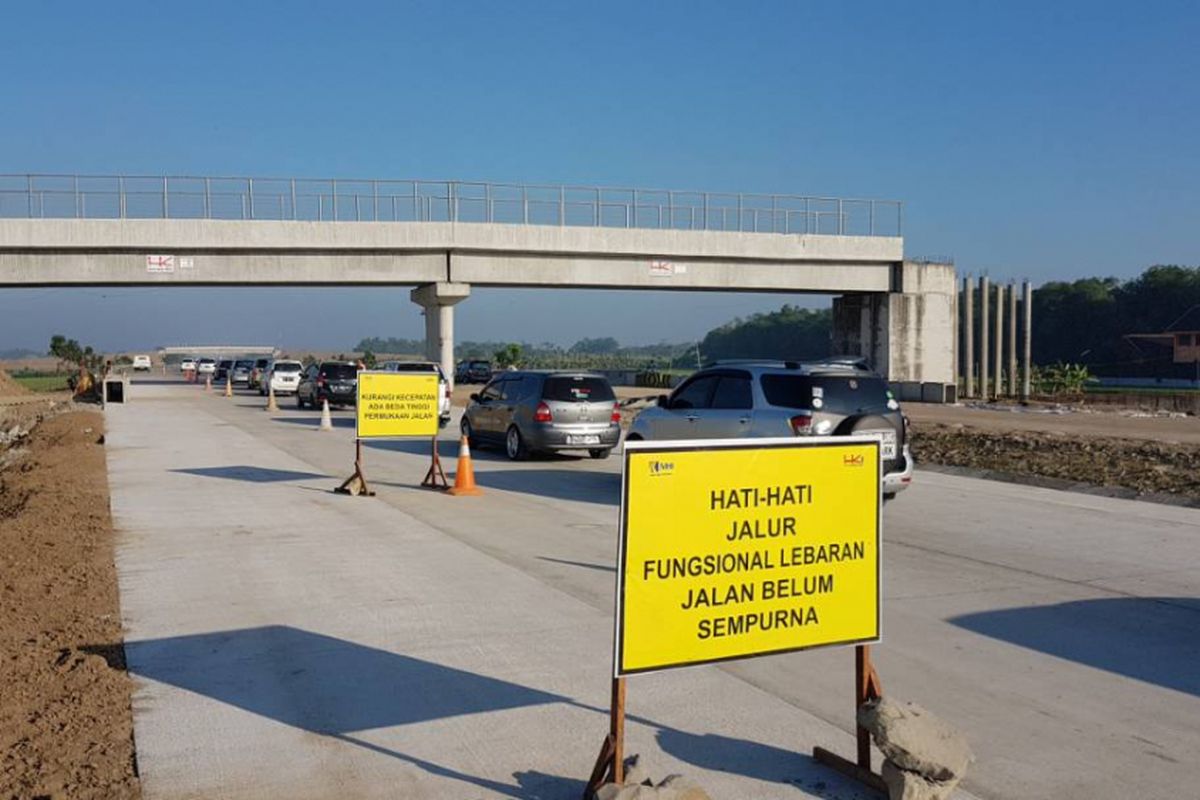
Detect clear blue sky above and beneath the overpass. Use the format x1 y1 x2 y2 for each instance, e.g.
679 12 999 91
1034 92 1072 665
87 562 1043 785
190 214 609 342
0 1 1200 349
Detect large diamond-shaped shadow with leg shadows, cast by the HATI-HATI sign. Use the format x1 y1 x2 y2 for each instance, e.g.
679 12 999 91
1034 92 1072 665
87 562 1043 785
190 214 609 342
98 625 858 800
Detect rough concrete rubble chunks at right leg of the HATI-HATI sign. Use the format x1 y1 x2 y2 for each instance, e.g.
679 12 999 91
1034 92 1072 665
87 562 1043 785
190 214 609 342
858 697 974 800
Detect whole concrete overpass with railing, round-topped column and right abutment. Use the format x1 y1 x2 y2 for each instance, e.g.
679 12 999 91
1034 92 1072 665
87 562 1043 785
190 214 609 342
0 175 956 399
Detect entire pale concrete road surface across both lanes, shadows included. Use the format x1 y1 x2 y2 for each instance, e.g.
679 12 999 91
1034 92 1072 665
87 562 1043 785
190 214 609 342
109 385 1200 800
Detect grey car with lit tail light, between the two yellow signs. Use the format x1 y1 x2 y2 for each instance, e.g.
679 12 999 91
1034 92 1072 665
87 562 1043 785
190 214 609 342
461 369 620 461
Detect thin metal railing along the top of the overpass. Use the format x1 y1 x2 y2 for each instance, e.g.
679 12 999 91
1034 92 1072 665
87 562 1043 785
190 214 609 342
0 175 904 236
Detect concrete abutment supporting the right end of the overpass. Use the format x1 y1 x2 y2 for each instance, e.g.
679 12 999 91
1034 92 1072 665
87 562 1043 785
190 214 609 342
833 261 958 403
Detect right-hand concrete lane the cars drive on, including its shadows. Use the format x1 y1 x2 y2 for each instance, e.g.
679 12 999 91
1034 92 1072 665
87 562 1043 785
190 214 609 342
180 381 1200 800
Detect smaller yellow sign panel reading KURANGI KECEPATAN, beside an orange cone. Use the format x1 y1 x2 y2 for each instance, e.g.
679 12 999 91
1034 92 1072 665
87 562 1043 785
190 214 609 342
358 372 438 439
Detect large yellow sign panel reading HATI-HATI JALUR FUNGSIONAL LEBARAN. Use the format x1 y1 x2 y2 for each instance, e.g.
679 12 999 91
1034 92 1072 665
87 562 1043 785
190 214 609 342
616 437 881 676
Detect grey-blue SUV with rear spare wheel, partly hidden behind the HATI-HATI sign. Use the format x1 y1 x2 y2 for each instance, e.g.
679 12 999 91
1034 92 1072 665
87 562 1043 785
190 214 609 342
628 359 913 498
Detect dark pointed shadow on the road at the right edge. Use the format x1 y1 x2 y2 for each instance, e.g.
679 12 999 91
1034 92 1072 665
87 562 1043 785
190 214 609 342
949 597 1200 696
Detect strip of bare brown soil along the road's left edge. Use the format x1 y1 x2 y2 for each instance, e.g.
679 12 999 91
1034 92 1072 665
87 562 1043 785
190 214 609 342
0 409 140 800
